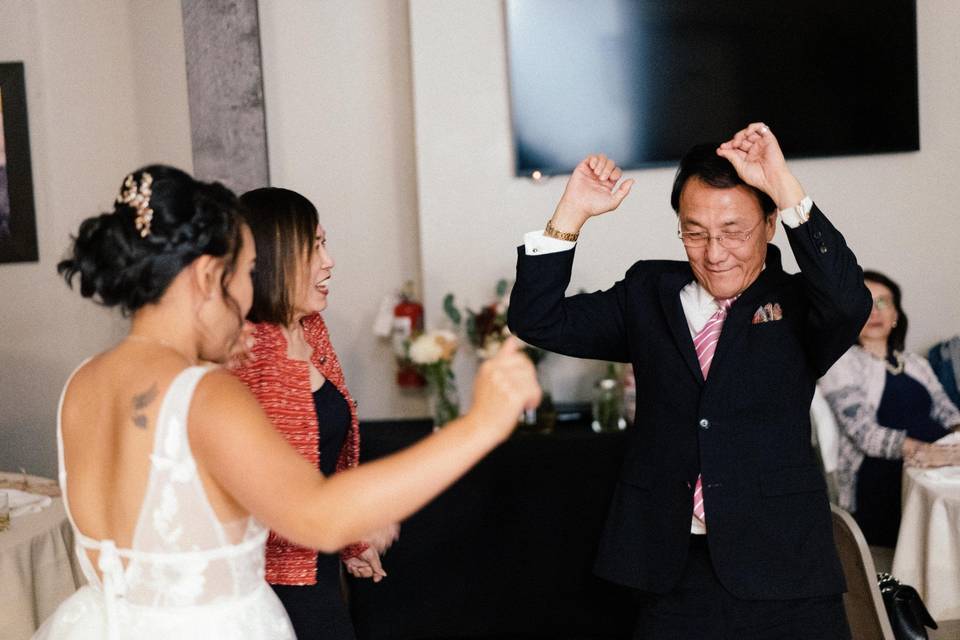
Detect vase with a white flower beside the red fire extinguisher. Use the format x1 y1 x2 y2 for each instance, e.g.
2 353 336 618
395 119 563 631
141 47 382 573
410 330 460 429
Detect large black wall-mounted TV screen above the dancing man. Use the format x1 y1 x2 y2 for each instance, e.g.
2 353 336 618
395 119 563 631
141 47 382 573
505 0 920 175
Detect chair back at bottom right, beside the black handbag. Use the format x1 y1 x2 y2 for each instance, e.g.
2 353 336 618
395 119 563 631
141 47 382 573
830 504 895 640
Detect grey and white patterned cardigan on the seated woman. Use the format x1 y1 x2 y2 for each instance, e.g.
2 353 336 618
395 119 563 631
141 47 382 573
819 346 960 512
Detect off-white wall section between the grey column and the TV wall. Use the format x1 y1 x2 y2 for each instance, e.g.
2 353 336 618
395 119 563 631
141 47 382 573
260 0 426 419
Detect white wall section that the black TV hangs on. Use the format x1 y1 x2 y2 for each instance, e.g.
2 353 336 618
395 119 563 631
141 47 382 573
410 0 960 398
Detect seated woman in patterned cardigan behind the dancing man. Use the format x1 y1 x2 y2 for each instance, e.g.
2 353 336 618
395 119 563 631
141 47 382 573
819 271 960 547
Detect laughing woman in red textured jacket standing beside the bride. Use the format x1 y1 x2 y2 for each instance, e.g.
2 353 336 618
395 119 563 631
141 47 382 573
234 188 396 640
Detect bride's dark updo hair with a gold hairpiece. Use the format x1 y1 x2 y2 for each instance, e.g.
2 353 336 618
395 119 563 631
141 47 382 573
57 165 242 315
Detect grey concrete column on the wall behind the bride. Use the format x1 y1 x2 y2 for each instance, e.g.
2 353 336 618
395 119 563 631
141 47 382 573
181 0 270 194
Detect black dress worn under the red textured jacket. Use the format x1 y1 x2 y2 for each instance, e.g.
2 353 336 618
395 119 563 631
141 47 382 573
271 381 356 640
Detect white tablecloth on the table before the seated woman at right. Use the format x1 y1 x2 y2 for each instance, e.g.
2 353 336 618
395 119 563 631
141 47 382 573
892 467 960 620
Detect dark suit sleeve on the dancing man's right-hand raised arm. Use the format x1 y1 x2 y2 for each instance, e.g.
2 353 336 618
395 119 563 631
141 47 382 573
785 206 873 376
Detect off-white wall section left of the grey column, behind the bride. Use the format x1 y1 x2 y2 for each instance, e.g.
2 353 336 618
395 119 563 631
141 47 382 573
0 0 190 476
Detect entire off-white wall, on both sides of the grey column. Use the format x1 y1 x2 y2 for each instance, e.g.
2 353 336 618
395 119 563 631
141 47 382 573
0 0 960 475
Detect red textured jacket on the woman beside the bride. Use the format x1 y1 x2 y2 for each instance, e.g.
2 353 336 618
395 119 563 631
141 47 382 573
234 314 367 585
